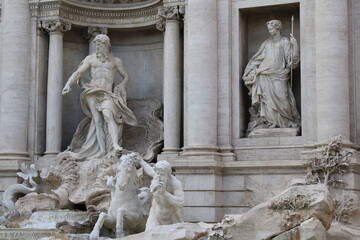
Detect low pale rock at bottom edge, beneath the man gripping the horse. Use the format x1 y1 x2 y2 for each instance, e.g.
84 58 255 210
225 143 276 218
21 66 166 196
122 222 212 240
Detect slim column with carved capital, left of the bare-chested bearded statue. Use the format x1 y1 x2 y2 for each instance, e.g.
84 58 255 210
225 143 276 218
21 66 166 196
42 20 71 156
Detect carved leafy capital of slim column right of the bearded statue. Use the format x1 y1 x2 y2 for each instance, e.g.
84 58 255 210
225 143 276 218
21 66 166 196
156 5 185 31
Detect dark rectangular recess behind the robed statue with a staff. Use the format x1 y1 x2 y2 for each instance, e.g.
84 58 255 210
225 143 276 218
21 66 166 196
238 3 302 138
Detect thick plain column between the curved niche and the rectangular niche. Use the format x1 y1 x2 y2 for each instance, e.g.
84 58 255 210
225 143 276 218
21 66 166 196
183 0 218 155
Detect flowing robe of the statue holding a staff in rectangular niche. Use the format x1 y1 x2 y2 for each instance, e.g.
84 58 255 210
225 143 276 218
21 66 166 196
244 36 300 128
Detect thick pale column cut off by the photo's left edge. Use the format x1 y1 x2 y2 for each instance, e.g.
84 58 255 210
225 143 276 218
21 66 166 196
0 0 30 163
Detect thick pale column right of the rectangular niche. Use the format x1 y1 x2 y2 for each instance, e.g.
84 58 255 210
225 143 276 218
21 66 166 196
315 0 350 142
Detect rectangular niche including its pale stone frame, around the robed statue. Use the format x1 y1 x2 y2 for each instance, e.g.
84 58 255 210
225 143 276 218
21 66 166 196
232 0 304 138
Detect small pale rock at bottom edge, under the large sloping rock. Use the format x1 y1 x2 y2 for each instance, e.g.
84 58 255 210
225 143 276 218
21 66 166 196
273 218 326 240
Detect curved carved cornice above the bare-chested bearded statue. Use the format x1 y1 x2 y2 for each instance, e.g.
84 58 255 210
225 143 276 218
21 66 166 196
30 0 169 28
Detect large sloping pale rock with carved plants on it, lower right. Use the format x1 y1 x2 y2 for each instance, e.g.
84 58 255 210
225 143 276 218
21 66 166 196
224 184 335 240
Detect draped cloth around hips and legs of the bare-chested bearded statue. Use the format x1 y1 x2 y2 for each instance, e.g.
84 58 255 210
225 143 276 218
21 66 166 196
69 83 137 159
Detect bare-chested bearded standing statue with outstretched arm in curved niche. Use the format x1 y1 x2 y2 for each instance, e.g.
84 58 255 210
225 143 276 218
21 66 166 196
62 34 137 159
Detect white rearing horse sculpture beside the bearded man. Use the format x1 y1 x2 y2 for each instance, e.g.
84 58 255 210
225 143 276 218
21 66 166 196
90 153 151 240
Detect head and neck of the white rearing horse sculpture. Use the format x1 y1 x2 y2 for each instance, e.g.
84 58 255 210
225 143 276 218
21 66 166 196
116 152 139 191
